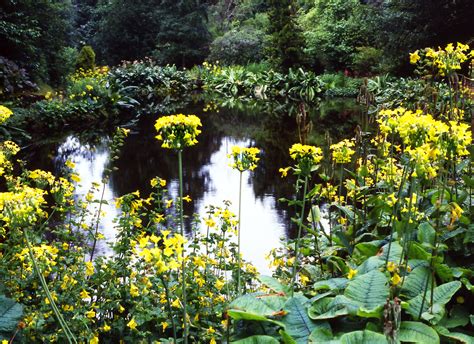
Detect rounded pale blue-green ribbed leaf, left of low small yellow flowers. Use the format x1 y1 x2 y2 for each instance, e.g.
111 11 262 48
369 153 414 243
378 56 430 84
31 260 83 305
344 270 390 310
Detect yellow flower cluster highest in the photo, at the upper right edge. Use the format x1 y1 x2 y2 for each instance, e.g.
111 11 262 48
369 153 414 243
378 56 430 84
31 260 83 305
410 42 474 76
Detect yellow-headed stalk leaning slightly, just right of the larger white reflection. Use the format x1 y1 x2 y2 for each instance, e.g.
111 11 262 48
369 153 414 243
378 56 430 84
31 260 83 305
283 143 323 295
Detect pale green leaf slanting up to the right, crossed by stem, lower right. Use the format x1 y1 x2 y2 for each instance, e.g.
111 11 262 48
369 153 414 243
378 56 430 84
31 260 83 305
407 281 461 319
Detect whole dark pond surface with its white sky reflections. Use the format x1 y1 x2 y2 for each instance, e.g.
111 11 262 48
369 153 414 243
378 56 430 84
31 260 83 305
22 99 363 273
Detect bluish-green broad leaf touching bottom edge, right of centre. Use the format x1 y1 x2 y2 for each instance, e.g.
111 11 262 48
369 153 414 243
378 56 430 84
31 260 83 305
281 297 329 343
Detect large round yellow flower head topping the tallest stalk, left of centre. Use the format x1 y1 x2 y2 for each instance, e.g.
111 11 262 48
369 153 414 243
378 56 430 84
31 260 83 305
155 114 202 149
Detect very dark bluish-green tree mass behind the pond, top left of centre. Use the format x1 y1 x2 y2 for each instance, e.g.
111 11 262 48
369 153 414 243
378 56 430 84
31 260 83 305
95 0 209 65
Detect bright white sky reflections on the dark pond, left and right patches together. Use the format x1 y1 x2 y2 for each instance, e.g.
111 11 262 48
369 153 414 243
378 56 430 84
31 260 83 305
58 137 285 274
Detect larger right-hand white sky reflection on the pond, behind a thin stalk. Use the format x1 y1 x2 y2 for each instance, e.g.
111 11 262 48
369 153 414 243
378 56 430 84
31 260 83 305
198 137 285 274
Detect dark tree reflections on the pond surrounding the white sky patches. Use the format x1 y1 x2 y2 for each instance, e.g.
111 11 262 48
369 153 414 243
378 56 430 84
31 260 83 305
25 100 360 236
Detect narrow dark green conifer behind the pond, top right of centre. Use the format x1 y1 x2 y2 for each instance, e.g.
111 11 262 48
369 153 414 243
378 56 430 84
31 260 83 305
266 0 304 70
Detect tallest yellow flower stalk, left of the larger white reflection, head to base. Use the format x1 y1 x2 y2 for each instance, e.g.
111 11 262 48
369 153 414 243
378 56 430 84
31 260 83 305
155 114 202 343
